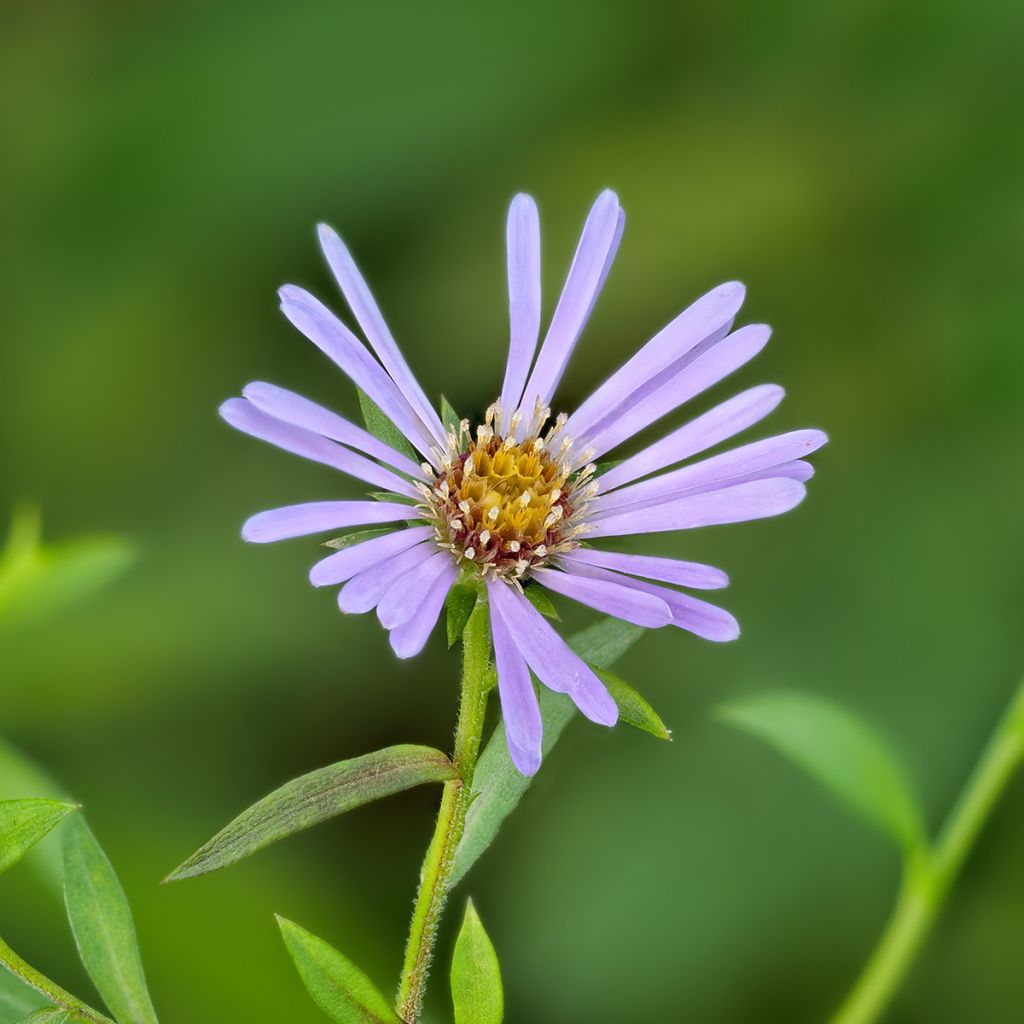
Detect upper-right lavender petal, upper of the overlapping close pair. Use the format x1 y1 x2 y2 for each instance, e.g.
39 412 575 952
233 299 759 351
565 281 745 438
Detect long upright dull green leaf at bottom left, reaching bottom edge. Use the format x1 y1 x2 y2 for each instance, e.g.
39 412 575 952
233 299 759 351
63 815 157 1024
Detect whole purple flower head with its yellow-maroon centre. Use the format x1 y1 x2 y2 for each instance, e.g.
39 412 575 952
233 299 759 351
221 191 826 775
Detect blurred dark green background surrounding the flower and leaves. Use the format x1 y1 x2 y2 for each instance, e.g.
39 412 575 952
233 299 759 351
0 0 1024 1024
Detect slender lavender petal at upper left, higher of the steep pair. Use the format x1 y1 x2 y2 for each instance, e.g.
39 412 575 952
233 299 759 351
317 224 444 447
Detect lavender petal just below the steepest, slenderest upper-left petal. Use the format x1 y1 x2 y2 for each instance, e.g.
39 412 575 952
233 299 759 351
278 285 437 458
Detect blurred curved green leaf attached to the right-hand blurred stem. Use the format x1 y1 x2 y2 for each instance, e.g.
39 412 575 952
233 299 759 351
718 692 924 850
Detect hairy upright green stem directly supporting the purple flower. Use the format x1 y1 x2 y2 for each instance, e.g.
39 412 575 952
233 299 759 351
395 596 490 1024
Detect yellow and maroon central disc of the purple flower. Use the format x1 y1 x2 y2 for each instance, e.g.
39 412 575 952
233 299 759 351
423 415 586 580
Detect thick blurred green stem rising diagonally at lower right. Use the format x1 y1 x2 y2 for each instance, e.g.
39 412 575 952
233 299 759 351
829 683 1024 1024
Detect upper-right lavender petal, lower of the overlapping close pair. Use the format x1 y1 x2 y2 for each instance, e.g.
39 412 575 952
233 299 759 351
587 324 771 459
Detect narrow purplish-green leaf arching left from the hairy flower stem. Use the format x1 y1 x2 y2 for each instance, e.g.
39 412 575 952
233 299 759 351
167 745 458 882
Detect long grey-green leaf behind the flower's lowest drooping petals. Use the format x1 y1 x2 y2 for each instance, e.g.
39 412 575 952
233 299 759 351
452 617 644 885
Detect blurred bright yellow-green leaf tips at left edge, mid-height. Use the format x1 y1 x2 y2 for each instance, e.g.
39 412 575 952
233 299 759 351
0 508 135 628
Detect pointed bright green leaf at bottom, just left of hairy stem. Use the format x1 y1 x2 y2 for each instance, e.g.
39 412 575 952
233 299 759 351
278 916 401 1024
